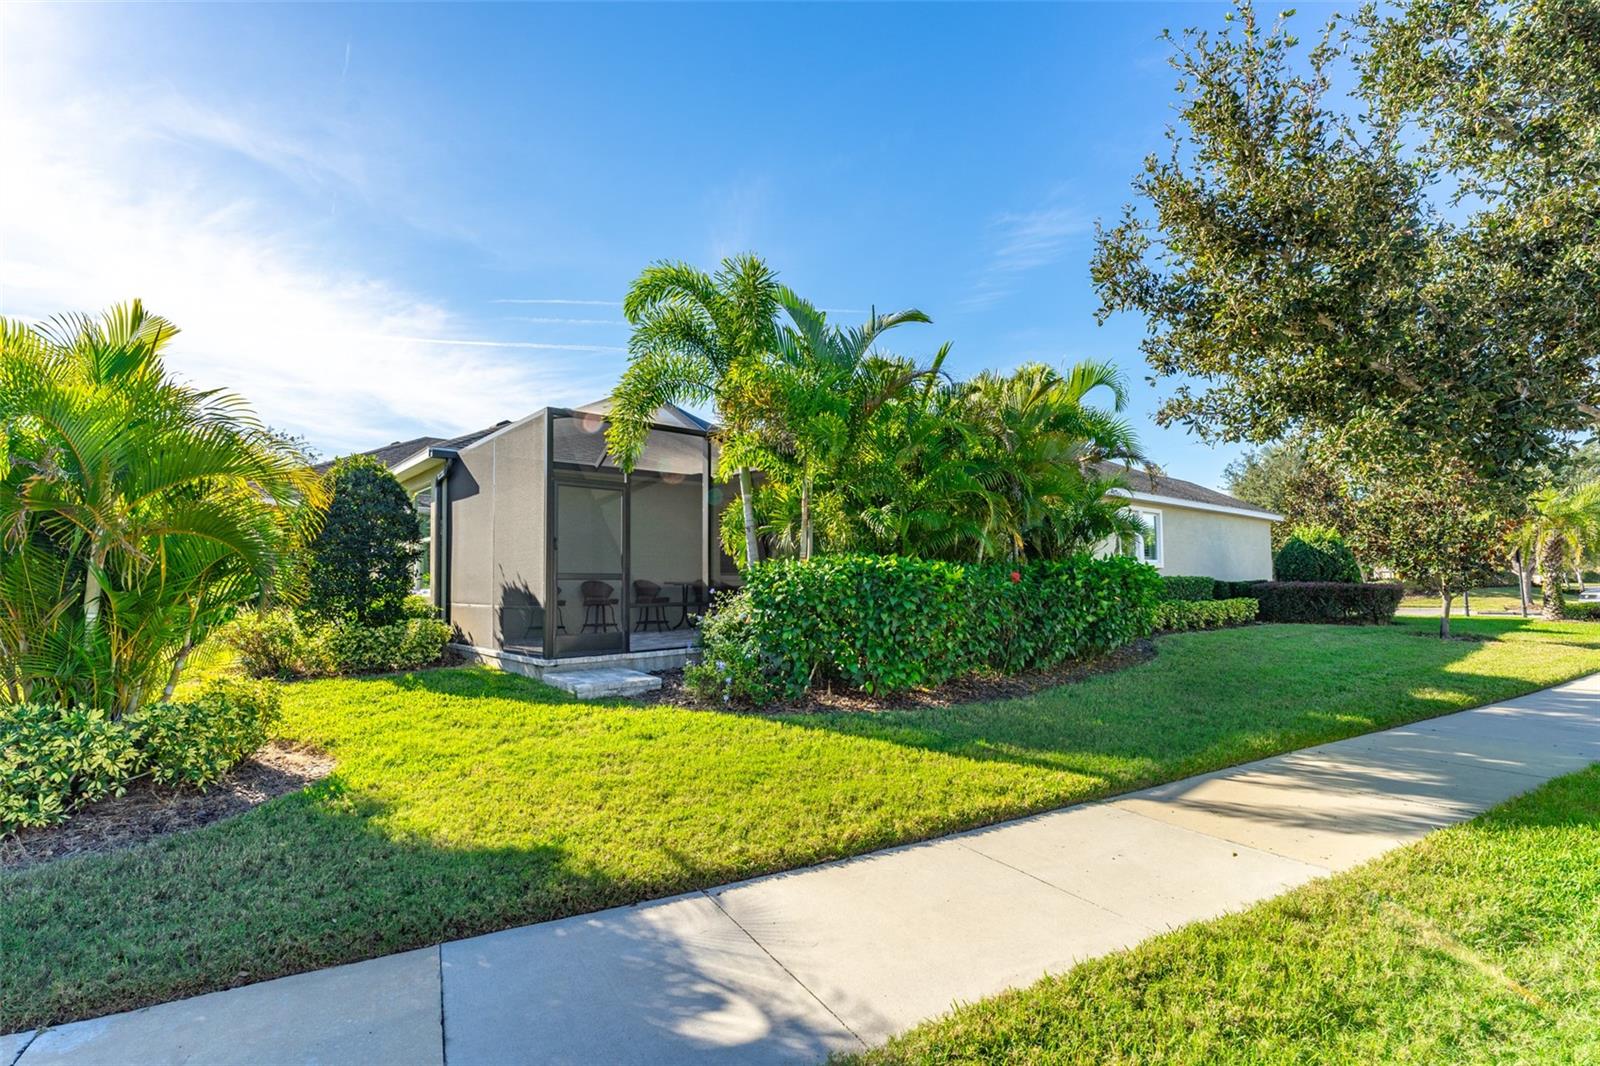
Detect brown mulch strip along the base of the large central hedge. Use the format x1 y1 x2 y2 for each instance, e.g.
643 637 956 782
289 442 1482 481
635 640 1155 714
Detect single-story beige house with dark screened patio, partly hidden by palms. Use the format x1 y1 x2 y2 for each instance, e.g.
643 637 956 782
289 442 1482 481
347 400 1278 672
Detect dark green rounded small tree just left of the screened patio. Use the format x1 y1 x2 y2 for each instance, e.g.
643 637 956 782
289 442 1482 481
306 455 422 626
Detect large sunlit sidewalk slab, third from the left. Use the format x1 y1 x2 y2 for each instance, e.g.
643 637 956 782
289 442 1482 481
710 839 1152 1044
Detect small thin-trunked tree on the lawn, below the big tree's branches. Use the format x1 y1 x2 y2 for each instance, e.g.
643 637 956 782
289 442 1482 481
1355 461 1509 639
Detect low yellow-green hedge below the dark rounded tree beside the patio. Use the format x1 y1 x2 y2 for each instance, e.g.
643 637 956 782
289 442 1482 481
218 597 450 679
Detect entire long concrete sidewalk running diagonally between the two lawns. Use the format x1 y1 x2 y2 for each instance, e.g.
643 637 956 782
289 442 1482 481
12 674 1600 1066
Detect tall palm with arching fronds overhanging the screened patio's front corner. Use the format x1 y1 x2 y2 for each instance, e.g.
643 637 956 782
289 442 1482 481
606 254 781 565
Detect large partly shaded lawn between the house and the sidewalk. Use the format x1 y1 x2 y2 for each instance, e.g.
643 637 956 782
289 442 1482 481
0 619 1600 1031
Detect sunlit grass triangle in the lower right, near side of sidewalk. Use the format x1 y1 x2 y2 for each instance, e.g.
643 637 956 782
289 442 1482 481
853 767 1600 1066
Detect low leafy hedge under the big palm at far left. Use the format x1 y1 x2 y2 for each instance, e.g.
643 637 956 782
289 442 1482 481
0 680 278 836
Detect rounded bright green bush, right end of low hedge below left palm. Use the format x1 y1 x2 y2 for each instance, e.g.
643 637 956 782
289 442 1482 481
126 680 278 789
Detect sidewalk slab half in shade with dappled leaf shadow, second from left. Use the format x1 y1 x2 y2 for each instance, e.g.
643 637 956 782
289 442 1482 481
442 893 861 1066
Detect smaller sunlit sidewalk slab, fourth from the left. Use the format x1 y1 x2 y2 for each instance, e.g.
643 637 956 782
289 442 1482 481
957 804 1328 930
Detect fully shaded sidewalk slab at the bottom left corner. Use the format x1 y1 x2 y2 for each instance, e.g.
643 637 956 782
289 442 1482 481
18 948 445 1066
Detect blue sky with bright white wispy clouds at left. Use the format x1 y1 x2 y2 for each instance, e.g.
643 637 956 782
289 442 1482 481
0 3 1350 485
